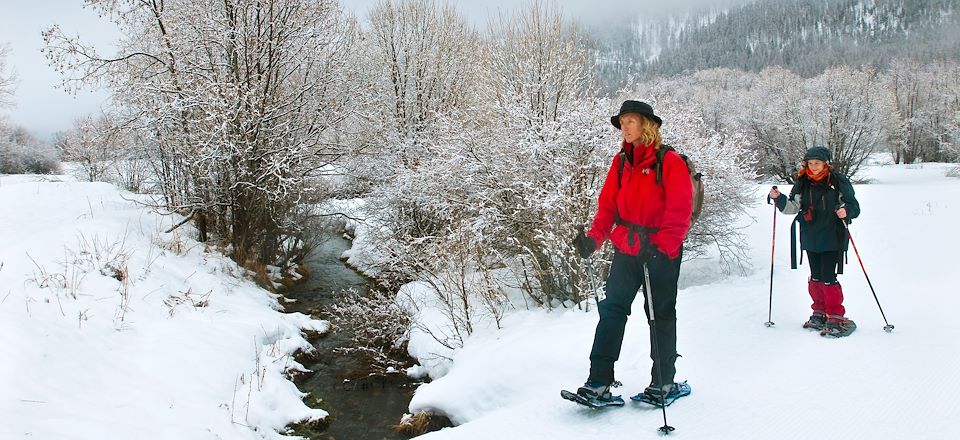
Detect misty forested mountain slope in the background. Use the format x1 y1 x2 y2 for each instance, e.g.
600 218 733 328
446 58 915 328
592 0 960 89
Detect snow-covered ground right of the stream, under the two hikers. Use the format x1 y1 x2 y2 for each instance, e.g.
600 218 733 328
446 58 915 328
411 164 960 440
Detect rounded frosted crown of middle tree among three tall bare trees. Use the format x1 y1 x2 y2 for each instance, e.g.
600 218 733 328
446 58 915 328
363 0 479 164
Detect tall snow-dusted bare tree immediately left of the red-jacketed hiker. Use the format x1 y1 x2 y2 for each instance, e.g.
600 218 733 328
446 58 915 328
473 1 600 307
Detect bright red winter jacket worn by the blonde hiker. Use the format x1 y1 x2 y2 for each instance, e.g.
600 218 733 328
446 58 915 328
588 142 693 259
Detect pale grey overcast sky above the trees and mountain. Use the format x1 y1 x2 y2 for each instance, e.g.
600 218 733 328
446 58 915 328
0 0 748 138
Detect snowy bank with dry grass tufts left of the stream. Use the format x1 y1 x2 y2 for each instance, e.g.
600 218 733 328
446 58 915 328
0 176 327 440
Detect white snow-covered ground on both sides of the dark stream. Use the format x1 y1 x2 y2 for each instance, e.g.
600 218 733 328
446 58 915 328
0 164 960 440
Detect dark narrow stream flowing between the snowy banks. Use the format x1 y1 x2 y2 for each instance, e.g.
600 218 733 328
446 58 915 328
284 232 414 440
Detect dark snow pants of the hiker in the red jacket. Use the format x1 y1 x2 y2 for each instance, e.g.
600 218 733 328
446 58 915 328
589 252 683 385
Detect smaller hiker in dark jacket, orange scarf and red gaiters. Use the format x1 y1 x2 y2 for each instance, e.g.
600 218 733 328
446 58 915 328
770 146 860 337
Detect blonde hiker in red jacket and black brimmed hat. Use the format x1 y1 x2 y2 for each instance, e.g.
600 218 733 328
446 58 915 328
574 101 693 404
